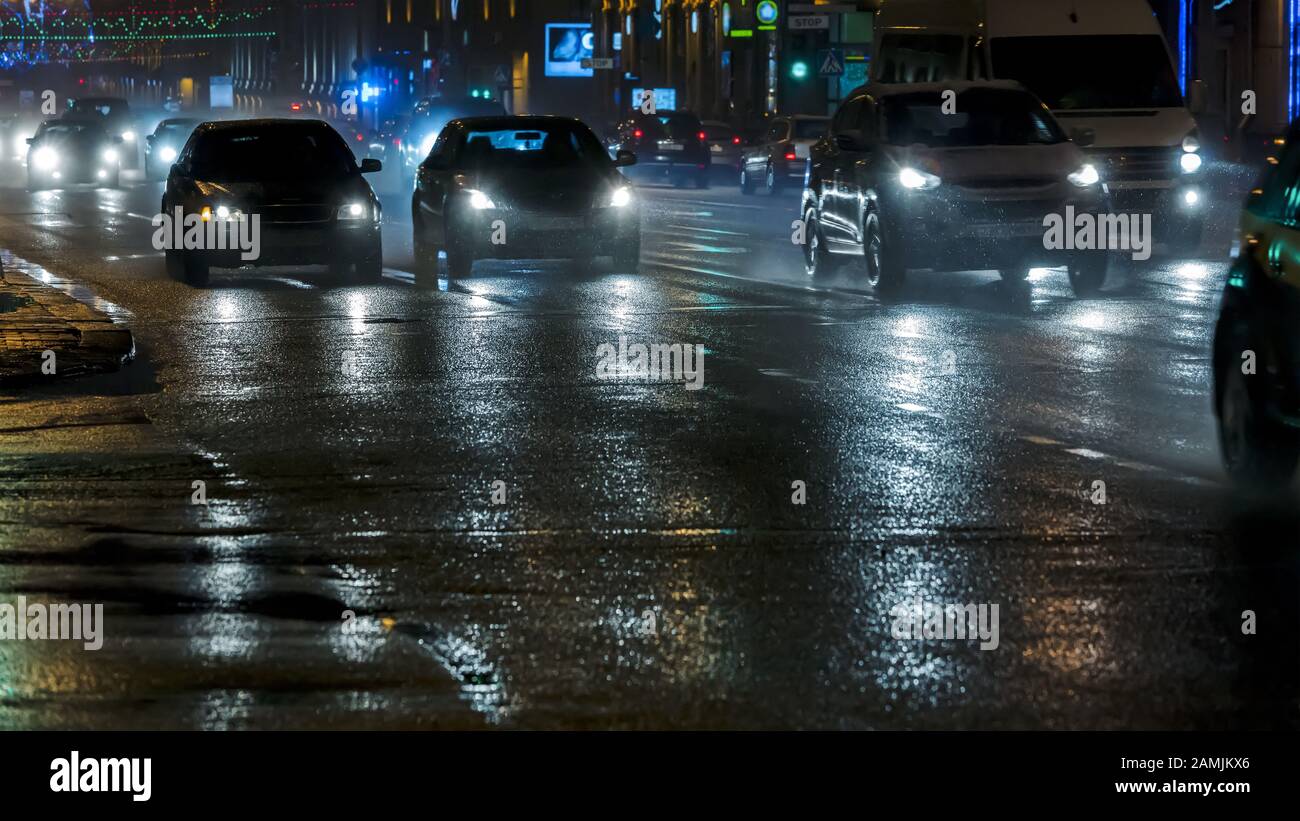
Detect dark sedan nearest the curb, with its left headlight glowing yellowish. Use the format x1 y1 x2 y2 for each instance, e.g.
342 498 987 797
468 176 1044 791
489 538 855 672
156 120 384 284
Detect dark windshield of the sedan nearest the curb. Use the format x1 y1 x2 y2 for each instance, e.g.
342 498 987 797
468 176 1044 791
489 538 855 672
191 126 356 182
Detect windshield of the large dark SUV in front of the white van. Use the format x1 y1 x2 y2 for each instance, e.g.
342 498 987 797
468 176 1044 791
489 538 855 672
881 88 1066 147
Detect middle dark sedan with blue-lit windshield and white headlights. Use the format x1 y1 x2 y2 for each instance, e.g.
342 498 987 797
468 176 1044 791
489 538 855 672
411 117 641 277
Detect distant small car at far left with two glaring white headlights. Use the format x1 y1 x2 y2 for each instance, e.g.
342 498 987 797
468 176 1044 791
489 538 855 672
27 117 122 191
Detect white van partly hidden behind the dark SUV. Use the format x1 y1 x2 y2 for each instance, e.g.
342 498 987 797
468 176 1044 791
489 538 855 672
871 0 1205 248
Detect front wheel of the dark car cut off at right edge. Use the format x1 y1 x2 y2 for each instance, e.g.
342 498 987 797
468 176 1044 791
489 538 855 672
1218 361 1300 494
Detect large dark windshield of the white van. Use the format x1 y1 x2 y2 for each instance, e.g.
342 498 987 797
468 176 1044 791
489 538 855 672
992 34 1183 110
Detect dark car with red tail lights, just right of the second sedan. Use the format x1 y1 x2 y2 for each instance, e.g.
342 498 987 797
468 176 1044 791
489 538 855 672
607 110 712 188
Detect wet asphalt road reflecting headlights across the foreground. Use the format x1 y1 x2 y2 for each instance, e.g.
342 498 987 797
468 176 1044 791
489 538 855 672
0 163 1300 729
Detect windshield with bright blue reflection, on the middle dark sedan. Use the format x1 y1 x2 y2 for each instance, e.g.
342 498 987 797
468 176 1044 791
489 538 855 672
458 123 608 170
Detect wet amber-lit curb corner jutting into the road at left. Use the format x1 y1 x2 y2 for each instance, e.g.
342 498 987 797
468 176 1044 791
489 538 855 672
0 253 135 382
